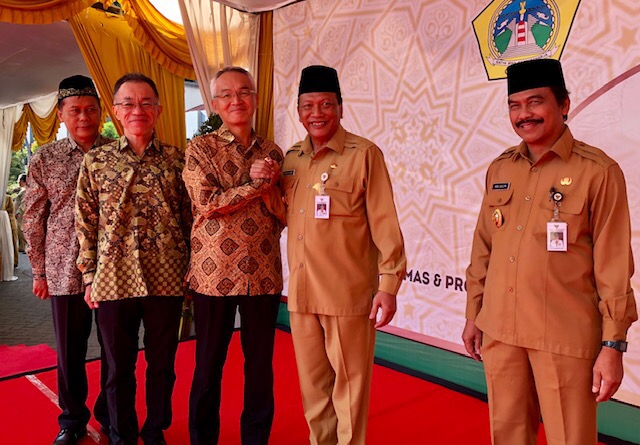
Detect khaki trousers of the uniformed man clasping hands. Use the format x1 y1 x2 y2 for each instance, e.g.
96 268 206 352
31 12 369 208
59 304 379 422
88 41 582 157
290 312 376 445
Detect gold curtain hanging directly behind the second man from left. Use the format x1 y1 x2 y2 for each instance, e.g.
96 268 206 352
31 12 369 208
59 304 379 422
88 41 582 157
69 8 187 148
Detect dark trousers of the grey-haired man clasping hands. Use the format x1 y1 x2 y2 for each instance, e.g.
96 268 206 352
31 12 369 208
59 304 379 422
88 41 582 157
189 294 280 445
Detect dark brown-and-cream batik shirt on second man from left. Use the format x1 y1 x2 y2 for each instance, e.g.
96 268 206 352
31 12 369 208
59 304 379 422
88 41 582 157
76 137 191 301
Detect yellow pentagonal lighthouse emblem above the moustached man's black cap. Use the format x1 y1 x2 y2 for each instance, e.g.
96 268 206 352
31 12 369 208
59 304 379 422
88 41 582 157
473 0 580 80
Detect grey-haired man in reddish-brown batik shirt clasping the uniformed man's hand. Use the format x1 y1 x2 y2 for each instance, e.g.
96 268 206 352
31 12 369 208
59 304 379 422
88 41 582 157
183 67 283 445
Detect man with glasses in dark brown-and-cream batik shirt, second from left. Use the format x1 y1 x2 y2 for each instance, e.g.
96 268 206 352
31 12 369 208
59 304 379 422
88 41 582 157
76 73 191 445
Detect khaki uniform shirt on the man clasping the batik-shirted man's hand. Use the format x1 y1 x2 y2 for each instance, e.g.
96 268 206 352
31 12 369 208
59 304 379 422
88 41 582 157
280 126 406 316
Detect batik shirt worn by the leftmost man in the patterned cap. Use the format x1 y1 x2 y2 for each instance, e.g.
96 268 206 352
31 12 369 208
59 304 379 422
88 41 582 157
22 136 113 295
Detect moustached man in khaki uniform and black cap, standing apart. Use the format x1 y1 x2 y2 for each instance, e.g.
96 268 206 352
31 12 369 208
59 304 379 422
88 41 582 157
462 59 638 445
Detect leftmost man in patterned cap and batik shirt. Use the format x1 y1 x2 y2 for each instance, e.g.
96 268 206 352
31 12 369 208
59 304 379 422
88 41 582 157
22 75 111 445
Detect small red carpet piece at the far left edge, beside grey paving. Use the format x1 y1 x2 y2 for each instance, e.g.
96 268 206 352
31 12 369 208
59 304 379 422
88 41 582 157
0 345 56 378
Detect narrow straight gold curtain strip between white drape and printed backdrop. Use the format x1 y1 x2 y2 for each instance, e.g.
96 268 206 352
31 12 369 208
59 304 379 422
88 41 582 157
256 11 274 140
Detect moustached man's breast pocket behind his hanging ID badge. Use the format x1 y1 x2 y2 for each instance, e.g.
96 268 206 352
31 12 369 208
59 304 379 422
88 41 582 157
535 194 589 244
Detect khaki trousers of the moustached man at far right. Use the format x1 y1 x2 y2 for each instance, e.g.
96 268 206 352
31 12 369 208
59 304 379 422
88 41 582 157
482 334 598 445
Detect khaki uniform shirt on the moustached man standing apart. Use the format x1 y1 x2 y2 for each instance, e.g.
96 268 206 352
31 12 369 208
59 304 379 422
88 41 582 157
466 128 637 358
